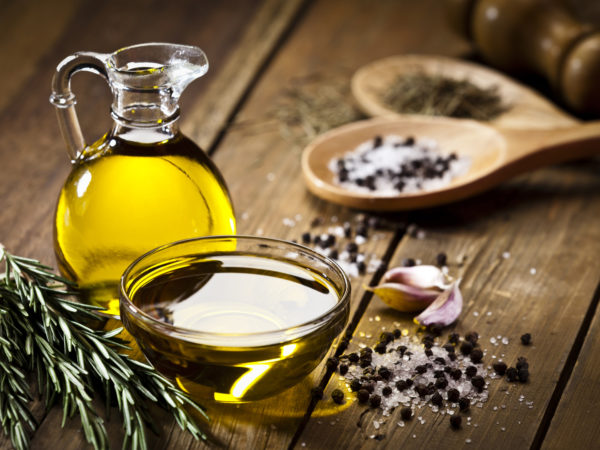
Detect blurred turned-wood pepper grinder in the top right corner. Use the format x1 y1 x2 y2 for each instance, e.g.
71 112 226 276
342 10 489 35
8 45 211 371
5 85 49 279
446 0 600 117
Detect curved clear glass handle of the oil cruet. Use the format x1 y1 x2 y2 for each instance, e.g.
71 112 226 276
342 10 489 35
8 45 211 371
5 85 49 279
50 52 110 162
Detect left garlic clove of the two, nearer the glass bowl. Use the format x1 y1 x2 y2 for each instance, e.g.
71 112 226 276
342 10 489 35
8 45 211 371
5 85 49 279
365 266 449 312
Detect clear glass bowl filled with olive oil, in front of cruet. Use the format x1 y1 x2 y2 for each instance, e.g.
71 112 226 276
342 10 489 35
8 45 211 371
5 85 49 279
120 236 350 403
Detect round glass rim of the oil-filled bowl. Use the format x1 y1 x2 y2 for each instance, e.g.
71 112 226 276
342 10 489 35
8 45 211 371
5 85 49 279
119 235 351 347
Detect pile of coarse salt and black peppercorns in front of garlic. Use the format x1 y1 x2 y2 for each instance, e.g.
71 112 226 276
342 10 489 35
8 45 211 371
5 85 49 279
327 327 531 428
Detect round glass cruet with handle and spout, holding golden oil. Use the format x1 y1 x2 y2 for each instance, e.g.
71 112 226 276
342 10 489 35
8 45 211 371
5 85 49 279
50 43 235 316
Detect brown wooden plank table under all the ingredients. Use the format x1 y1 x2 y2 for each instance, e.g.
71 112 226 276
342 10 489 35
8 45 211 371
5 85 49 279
0 0 600 450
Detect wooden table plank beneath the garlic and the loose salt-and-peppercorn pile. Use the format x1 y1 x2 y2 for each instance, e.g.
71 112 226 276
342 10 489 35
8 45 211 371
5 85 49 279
298 163 600 448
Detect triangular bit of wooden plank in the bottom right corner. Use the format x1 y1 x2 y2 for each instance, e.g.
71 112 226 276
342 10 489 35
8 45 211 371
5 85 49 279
542 293 600 449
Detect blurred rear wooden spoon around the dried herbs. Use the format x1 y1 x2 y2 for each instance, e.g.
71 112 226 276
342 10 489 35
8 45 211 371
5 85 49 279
352 55 578 129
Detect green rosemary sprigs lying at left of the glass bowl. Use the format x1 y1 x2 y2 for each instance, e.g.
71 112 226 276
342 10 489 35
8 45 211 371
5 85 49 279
0 244 208 449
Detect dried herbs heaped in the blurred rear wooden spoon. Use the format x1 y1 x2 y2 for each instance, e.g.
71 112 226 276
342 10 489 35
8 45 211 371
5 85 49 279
380 73 508 121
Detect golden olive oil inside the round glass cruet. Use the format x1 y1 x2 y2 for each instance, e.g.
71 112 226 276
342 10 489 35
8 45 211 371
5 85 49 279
54 132 235 315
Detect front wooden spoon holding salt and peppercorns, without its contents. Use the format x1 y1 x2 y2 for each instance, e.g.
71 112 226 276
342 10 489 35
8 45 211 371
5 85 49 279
302 116 600 211
